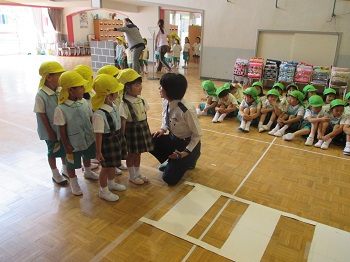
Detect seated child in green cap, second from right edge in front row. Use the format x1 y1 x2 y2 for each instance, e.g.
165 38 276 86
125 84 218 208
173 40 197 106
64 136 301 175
315 99 345 149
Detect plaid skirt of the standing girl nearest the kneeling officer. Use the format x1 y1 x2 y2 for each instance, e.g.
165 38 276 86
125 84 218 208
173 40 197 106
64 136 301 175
125 120 154 153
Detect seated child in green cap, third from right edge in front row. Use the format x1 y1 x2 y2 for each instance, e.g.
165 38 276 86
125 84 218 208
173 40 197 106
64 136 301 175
283 95 331 146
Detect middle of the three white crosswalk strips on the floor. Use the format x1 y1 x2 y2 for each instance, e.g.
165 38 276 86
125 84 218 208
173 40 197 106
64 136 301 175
220 203 281 261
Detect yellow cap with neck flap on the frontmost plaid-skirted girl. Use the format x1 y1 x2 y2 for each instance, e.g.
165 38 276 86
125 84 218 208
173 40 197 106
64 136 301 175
91 74 124 110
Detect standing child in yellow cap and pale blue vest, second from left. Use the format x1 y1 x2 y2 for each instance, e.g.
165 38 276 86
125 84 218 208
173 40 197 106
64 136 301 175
54 71 99 196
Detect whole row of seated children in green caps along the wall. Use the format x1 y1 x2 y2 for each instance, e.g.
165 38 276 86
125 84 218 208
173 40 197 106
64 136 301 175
197 80 350 155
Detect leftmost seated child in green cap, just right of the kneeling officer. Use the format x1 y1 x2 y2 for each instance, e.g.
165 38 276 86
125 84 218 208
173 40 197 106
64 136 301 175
196 80 219 116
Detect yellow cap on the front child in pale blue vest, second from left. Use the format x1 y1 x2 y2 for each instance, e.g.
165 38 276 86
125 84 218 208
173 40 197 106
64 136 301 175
58 71 88 104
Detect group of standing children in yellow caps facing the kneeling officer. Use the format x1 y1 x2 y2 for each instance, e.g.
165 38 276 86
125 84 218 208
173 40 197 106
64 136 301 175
34 61 153 201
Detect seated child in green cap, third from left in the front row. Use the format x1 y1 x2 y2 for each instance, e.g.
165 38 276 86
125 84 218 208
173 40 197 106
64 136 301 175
237 87 260 133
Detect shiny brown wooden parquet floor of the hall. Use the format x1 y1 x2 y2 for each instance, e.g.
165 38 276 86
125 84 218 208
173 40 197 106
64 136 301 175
0 56 350 261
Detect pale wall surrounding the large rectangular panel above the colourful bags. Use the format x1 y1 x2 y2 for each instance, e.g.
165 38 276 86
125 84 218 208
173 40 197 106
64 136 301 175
122 0 350 79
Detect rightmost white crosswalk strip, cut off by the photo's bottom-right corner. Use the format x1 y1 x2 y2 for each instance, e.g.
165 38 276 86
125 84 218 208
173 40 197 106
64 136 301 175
308 223 350 262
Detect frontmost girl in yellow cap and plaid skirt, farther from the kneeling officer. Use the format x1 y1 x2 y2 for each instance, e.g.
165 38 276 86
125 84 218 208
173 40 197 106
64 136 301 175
91 74 126 201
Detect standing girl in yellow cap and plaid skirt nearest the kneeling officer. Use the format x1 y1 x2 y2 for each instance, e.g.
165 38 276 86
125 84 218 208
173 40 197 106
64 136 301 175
117 69 153 185
